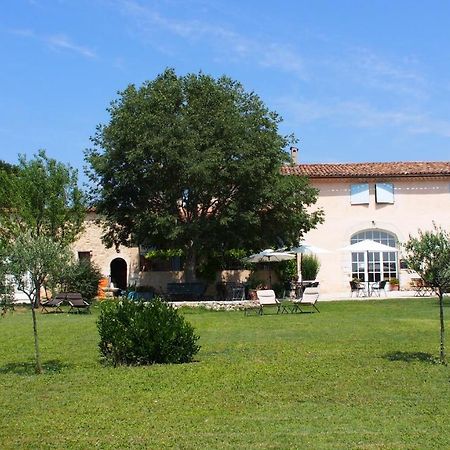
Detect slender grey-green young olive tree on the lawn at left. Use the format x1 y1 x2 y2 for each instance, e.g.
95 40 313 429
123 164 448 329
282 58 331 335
6 232 72 373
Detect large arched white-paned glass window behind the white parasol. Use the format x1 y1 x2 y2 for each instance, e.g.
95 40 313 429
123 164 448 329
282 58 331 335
350 229 398 282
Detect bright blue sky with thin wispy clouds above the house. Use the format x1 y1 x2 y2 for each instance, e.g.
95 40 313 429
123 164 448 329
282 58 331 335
0 0 450 183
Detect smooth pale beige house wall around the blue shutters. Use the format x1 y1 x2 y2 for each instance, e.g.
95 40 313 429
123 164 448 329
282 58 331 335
304 178 450 293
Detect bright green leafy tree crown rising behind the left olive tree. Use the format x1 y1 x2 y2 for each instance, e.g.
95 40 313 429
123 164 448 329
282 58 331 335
0 150 86 245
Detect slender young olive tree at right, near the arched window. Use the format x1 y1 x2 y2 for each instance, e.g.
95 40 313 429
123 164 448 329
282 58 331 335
405 225 450 364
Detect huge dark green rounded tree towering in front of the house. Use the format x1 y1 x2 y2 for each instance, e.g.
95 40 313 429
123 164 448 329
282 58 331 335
86 69 322 279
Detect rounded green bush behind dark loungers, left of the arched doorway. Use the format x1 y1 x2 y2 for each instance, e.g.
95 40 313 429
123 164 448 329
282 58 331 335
59 261 103 301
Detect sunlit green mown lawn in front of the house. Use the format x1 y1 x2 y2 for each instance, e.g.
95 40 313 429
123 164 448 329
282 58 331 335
0 299 450 449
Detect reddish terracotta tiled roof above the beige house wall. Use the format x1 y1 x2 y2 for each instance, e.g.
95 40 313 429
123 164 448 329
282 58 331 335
281 161 450 178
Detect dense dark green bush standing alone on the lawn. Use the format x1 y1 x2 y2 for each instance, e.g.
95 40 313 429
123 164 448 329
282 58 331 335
97 299 200 366
